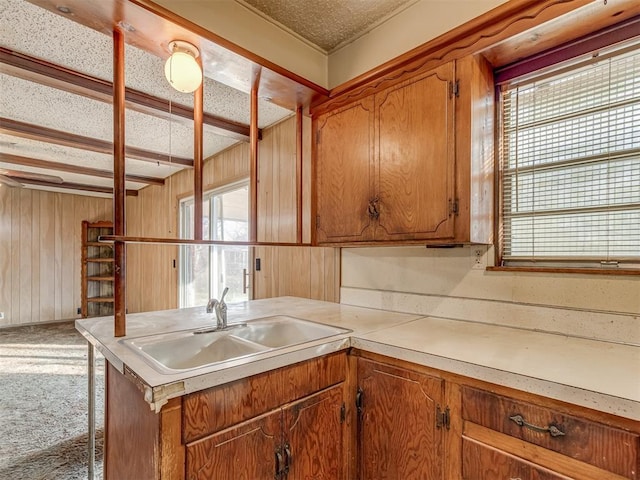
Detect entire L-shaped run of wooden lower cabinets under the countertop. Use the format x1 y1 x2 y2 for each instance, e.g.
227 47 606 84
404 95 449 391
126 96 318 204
104 349 640 480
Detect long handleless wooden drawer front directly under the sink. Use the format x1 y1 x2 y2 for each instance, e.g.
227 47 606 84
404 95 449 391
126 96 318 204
182 352 347 443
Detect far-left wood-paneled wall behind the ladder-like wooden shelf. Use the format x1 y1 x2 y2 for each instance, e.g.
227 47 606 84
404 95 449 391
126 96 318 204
0 186 111 327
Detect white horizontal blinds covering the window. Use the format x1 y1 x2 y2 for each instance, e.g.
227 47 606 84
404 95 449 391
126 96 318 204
500 48 640 266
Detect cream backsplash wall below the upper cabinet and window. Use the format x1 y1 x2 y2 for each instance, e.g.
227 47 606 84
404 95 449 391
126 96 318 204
340 245 640 345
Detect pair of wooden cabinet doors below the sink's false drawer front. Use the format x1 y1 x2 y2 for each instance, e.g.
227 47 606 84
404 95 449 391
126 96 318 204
187 385 345 480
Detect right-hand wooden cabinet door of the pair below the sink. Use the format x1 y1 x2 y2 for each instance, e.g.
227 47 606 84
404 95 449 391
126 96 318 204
284 385 345 480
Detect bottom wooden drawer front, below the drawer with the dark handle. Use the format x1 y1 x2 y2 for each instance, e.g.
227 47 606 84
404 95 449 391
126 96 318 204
462 438 571 480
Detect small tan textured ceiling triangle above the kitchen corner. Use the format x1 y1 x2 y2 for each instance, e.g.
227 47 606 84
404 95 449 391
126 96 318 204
236 0 417 52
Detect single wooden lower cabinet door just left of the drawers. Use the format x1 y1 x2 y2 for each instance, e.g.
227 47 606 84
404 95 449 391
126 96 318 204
358 359 443 480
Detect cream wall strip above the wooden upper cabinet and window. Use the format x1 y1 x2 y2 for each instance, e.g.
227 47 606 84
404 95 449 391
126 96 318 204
329 0 506 88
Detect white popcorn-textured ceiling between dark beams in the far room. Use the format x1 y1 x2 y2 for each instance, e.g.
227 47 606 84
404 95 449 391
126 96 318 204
0 0 292 194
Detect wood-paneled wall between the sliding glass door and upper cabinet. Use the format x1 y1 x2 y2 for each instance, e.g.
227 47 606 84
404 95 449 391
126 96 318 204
253 117 340 302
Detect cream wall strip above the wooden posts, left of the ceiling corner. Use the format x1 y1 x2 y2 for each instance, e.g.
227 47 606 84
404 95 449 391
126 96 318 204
155 0 328 87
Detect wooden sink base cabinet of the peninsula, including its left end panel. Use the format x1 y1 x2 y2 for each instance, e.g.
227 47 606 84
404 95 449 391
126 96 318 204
104 352 351 480
